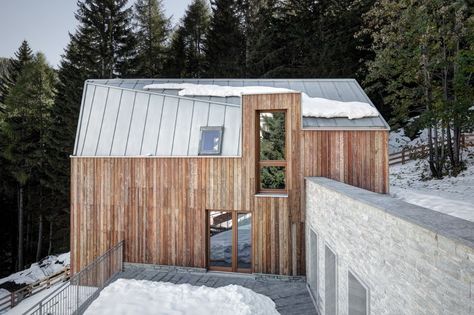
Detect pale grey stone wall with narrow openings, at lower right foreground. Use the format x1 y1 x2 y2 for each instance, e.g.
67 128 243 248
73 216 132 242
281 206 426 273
306 177 474 315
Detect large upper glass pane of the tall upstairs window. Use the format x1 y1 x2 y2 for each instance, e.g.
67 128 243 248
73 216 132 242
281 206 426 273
260 112 285 161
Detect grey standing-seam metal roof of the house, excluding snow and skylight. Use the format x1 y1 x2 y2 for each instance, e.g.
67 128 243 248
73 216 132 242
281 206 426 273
74 79 389 156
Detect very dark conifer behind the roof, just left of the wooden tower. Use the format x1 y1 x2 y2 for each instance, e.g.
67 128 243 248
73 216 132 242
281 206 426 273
205 0 246 78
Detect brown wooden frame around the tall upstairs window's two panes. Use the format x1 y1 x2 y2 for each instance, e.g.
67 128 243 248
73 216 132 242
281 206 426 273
255 109 289 194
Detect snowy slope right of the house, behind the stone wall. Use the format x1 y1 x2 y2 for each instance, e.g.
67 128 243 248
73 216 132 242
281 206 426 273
390 147 474 222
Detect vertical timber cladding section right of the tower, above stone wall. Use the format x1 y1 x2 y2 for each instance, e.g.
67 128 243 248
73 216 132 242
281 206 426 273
301 130 389 193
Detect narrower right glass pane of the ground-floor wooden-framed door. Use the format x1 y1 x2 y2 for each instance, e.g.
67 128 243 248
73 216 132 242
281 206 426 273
237 213 252 269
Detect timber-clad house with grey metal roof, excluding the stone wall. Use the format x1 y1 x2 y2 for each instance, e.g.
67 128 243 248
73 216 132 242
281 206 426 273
71 79 389 275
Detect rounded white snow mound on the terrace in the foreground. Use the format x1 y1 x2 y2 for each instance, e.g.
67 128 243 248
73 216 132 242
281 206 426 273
85 279 279 315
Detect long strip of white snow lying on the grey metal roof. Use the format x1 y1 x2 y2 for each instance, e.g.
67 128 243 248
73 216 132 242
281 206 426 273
143 83 379 119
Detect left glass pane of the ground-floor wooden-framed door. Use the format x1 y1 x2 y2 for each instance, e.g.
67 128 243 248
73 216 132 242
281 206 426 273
209 211 232 267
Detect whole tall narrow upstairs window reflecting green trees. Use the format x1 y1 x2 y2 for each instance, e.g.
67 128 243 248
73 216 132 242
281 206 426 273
256 111 287 193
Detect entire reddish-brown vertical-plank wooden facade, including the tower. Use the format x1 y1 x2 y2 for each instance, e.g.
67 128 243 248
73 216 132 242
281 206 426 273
71 93 388 275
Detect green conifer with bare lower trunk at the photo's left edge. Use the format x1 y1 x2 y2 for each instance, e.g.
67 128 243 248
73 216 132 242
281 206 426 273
1 54 55 269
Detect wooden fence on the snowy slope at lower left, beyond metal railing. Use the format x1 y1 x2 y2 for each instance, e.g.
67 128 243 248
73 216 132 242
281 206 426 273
0 267 70 314
